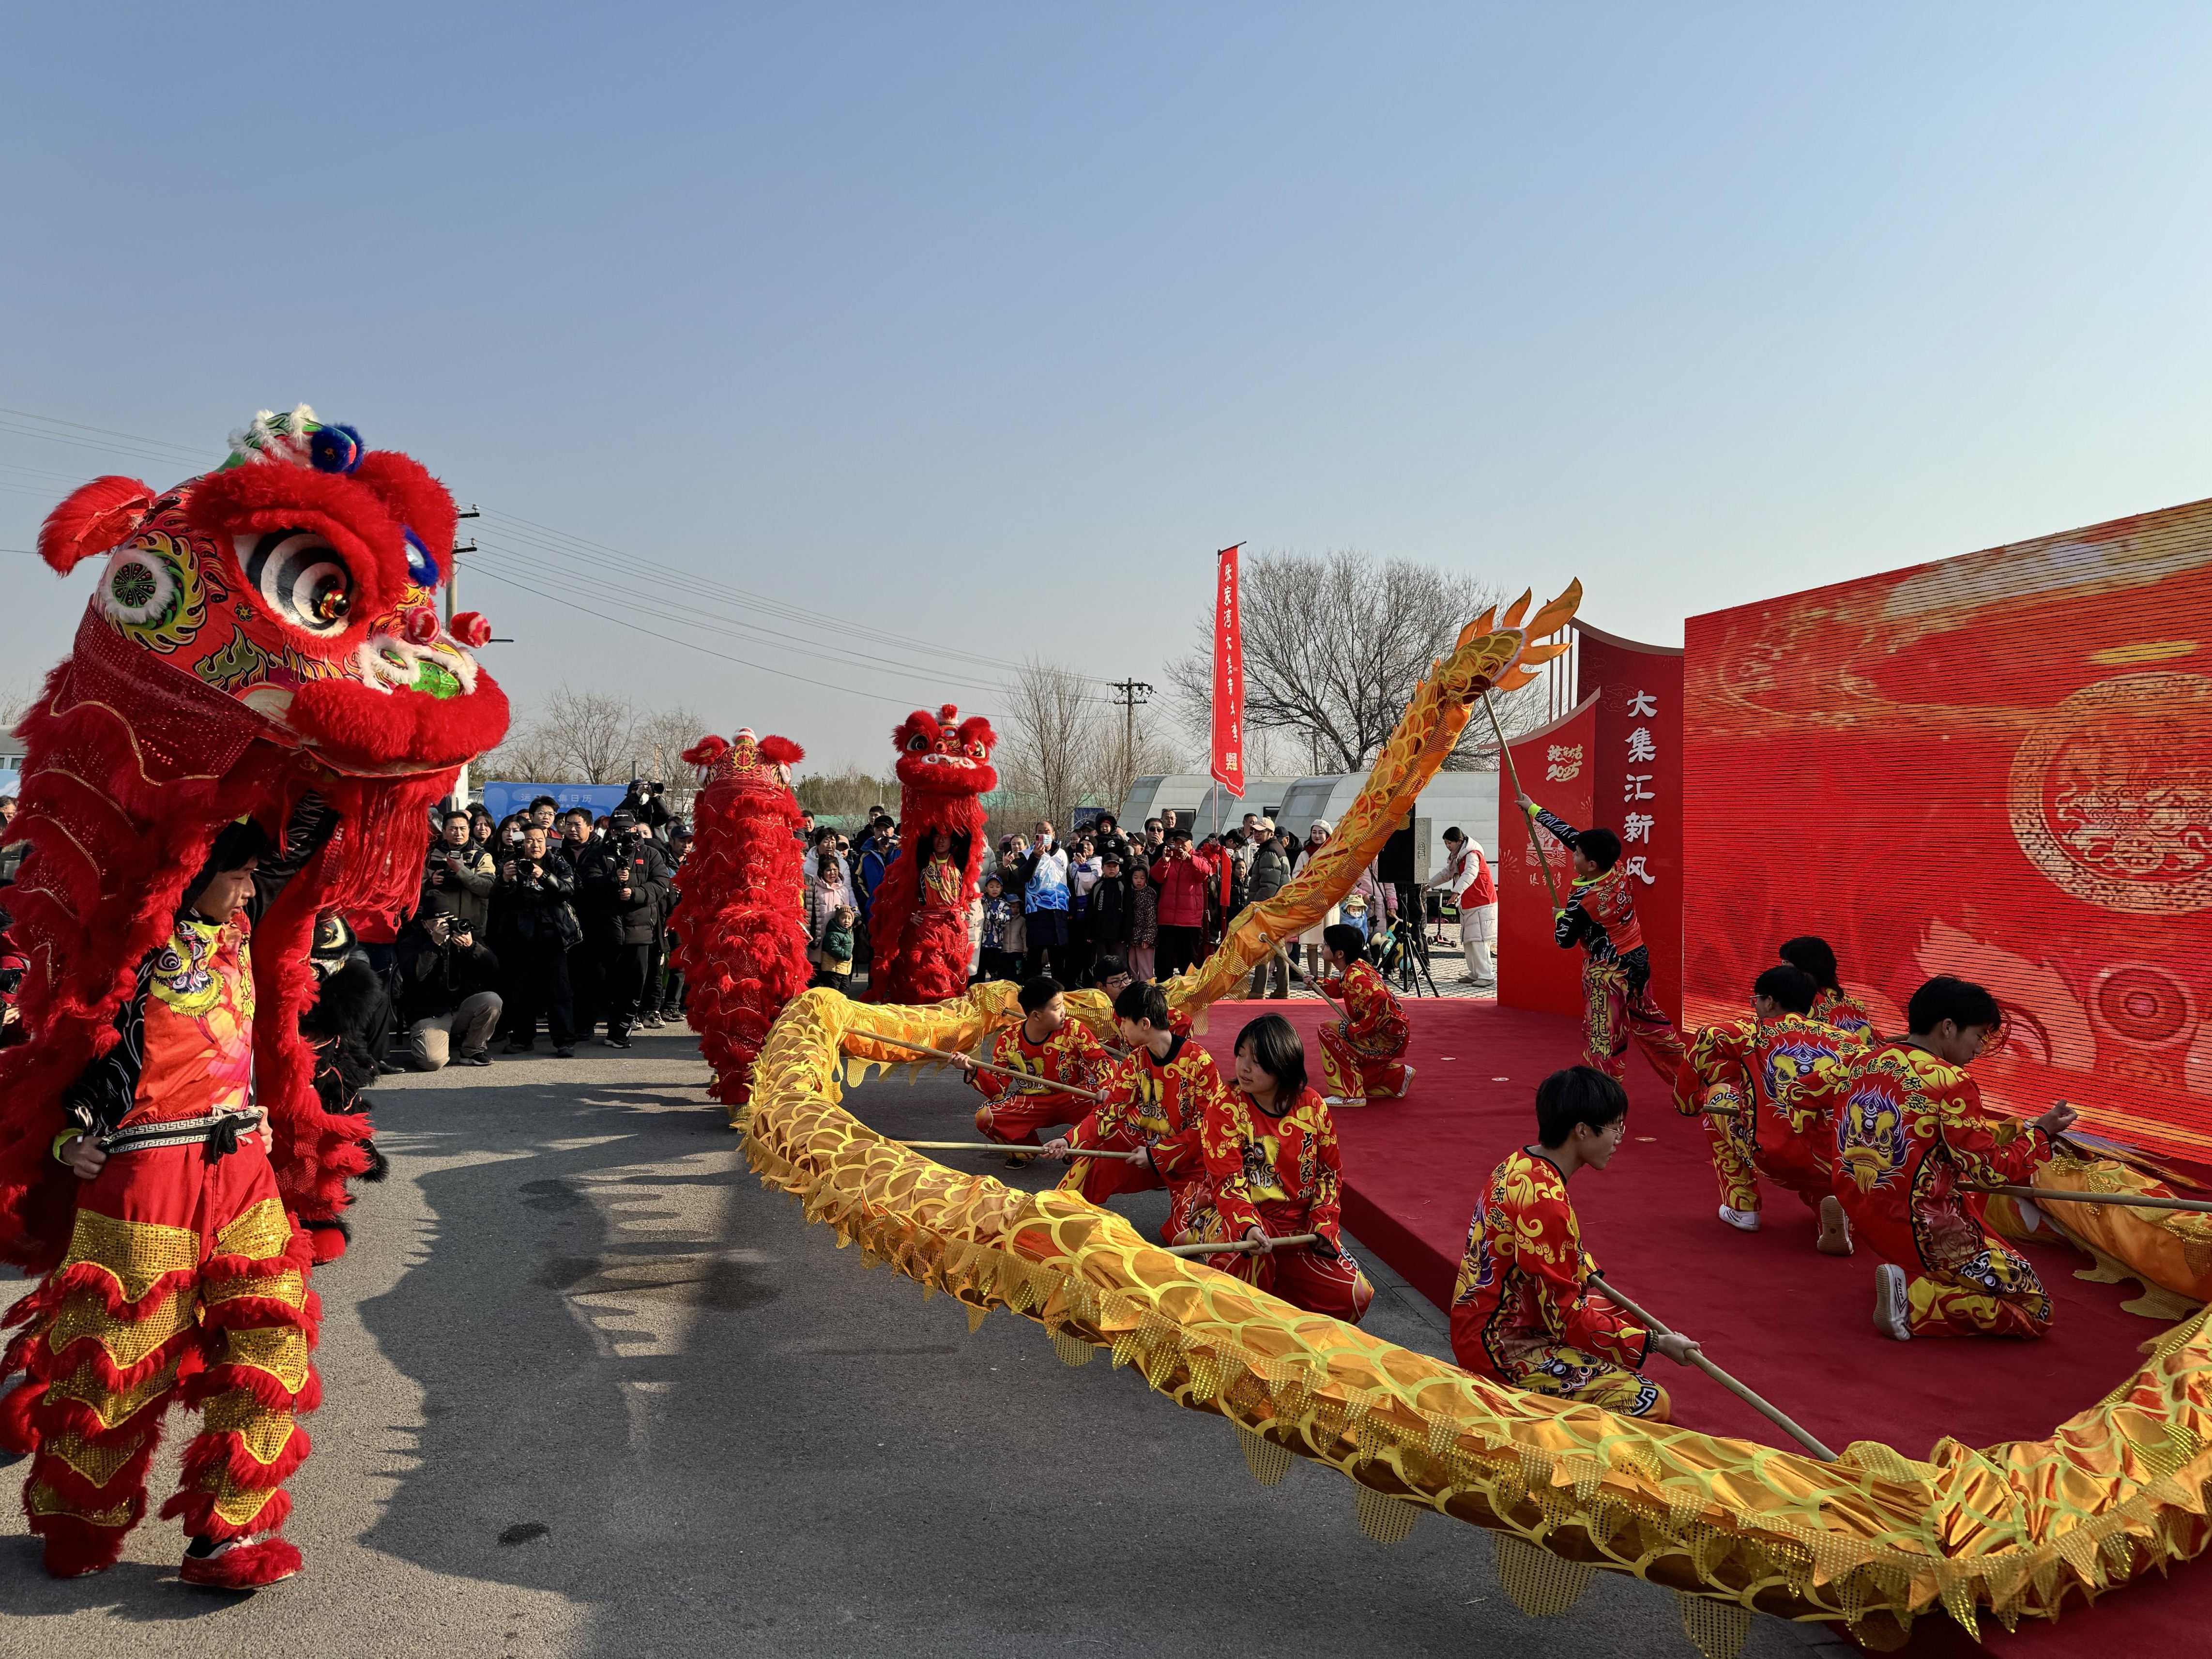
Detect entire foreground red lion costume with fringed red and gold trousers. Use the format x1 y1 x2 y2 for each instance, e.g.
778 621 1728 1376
0 405 506 1588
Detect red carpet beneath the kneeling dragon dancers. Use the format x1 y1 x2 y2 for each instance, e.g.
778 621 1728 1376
1205 1000 2212 1655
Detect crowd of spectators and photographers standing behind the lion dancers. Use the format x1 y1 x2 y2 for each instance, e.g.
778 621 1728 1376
0 781 1433 1071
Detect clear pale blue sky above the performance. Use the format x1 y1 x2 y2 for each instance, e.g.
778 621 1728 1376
0 4 2212 765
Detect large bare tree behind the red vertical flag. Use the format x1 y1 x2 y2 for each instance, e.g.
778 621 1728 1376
1168 551 1533 772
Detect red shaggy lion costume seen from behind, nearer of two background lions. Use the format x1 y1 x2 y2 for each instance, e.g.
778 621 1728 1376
672 730 814 1106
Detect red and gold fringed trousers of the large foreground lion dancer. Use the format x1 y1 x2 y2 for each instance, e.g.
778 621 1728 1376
0 1142 321 1575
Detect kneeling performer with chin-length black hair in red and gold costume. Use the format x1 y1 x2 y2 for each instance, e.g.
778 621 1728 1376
1199 1013 1376 1325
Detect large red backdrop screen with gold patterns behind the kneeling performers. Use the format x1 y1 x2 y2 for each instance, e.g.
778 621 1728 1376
1681 502 2212 1159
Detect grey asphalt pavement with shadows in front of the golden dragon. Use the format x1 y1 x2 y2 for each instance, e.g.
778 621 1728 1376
0 1031 1847 1659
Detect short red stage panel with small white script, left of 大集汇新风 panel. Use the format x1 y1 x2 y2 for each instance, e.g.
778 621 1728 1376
1497 697 1602 1018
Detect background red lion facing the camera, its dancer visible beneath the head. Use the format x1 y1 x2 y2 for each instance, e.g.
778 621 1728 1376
867 703 998 1002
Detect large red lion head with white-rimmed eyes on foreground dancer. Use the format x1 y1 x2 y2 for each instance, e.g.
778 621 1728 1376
38 405 506 776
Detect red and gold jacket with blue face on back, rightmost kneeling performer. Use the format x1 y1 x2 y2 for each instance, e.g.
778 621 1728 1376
1836 1042 2050 1274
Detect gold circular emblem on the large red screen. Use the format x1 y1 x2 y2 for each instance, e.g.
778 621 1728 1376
2006 675 2212 916
